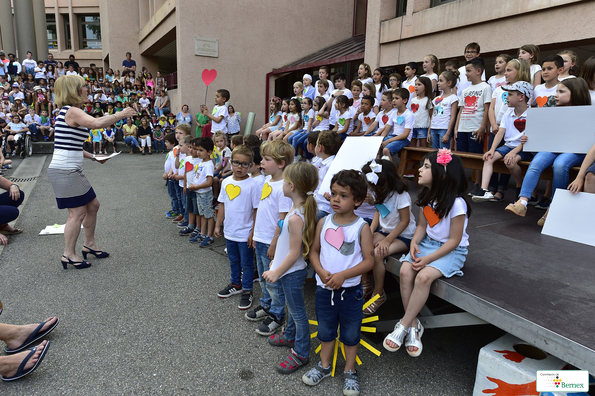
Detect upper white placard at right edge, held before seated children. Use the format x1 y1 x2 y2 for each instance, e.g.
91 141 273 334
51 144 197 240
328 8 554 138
523 106 595 154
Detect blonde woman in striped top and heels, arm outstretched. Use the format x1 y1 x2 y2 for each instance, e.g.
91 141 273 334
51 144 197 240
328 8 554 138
48 75 136 269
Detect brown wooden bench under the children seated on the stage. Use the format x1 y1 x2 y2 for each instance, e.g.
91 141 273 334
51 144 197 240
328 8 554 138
398 147 580 180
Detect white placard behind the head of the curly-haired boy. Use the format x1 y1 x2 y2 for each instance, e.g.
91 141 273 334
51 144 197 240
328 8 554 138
318 136 382 195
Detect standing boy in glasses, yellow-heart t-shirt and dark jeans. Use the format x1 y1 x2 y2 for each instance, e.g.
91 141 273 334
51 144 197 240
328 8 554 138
215 145 261 310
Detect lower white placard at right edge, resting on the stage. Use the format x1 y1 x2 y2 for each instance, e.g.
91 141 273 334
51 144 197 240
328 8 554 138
541 188 595 246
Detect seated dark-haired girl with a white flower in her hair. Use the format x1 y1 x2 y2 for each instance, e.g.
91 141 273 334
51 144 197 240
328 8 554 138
362 160 415 315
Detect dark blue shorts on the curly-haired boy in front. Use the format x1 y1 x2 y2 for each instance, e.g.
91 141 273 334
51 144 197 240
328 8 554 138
315 283 364 346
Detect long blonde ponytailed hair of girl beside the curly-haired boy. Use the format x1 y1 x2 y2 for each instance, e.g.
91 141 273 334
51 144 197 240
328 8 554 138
283 162 318 258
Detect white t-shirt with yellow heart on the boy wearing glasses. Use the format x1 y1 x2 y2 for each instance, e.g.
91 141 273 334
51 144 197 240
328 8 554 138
217 176 260 242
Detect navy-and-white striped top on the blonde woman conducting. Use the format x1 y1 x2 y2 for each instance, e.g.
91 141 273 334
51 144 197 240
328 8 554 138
49 106 89 169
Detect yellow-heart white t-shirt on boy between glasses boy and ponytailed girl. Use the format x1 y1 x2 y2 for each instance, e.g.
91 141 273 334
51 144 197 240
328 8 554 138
253 176 293 245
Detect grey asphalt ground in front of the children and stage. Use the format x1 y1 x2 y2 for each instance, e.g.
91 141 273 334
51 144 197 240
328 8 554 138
0 154 503 395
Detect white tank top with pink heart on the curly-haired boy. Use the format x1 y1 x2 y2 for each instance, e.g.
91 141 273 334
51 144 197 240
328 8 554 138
318 214 366 290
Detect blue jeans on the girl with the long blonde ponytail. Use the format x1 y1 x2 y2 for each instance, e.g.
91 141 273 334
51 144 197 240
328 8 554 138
277 268 310 358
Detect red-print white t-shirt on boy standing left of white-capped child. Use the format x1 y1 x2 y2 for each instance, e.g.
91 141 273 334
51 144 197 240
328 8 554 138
459 81 492 132
